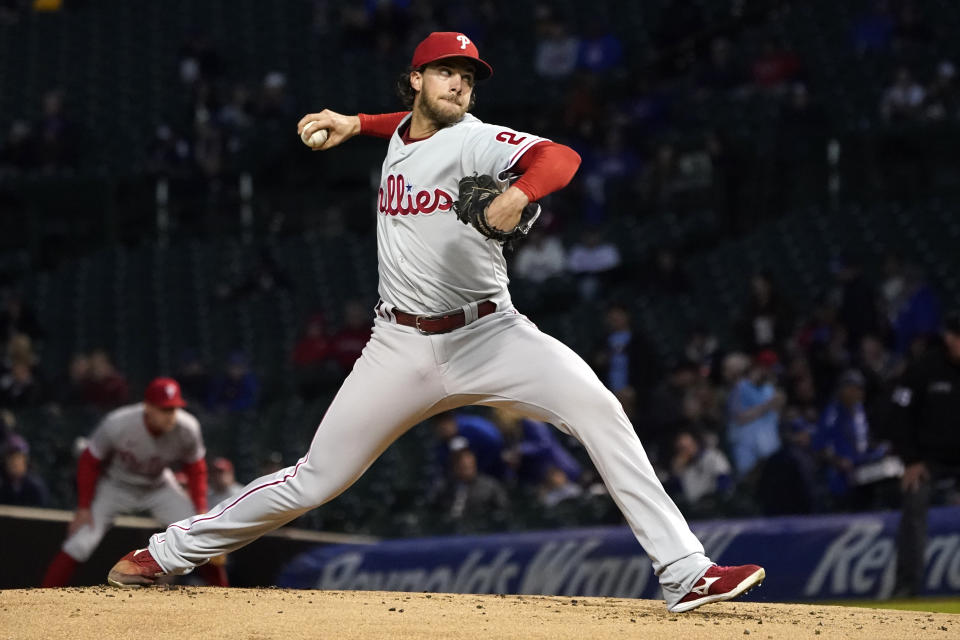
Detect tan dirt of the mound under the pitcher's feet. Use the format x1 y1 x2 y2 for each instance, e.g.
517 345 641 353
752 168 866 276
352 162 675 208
0 587 960 640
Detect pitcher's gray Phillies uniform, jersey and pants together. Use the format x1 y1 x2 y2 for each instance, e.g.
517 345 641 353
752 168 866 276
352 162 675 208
149 114 711 605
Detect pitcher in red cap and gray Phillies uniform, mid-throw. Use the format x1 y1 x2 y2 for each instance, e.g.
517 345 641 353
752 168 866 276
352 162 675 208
108 33 764 611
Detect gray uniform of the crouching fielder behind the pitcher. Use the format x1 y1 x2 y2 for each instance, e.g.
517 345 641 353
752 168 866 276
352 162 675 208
63 403 206 562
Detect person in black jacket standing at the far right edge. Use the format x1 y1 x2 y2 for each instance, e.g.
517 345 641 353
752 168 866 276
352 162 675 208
890 311 960 596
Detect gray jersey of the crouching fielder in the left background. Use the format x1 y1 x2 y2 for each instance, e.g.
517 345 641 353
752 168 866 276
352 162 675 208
89 403 207 487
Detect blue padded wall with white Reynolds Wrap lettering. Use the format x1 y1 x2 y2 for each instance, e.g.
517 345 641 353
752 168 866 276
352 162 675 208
278 507 960 601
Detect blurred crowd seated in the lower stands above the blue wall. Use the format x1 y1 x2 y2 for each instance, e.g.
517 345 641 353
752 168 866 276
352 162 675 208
0 244 944 530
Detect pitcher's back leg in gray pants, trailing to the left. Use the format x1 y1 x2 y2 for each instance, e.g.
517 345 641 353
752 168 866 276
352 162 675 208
143 320 443 573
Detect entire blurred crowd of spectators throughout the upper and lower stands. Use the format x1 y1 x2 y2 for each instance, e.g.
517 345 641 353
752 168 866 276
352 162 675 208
0 0 960 530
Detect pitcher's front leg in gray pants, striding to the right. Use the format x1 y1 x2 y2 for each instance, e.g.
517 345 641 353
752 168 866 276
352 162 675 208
451 314 744 605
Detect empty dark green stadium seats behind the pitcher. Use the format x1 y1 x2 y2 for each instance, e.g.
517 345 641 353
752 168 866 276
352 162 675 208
0 0 960 534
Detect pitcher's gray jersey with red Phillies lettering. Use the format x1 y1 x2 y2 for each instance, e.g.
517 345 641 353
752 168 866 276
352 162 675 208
377 114 544 314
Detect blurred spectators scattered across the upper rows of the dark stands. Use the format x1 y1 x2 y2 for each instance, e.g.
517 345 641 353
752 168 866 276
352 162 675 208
0 0 960 220
